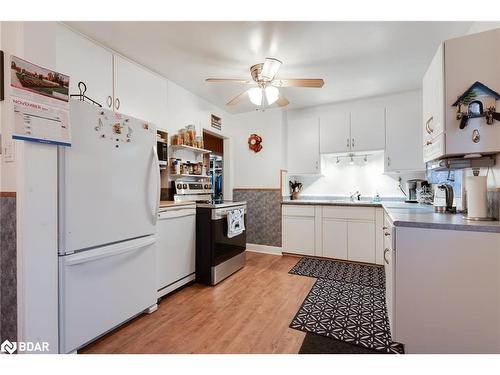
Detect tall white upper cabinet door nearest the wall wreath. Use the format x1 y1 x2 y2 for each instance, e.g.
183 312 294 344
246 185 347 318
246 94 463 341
287 115 320 175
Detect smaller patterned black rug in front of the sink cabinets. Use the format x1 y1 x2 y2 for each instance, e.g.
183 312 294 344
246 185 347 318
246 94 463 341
288 258 385 288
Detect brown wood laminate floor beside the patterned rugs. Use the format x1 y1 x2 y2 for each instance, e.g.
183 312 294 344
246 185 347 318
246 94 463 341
79 252 316 354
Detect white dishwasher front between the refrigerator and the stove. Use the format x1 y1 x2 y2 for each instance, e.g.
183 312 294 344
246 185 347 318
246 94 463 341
156 206 196 291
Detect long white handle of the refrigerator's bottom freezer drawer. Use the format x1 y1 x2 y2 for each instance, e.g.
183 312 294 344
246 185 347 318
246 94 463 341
64 237 156 266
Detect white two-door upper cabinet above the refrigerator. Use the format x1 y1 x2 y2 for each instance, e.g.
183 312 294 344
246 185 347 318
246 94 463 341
56 25 167 129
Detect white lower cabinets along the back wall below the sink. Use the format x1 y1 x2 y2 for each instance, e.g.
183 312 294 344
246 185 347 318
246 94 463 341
282 204 383 264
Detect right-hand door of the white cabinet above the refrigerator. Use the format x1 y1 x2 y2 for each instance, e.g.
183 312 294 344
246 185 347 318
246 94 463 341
114 55 167 129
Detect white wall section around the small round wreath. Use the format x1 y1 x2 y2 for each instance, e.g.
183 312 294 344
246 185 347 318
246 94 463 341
230 109 285 189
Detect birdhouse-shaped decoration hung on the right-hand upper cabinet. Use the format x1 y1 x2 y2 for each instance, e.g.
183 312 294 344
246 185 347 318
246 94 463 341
453 81 500 129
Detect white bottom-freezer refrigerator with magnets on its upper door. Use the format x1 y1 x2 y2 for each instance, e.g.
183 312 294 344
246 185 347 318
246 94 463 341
58 101 160 353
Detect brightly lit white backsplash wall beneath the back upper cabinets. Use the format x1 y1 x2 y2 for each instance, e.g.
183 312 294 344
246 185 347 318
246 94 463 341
290 151 424 197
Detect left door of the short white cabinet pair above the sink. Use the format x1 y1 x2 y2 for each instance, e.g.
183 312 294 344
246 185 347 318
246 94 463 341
319 109 351 153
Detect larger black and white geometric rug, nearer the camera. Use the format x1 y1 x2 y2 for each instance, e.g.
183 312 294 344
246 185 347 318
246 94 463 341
290 279 404 354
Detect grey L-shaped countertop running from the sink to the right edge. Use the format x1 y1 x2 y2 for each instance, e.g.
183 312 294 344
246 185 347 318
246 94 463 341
282 198 500 233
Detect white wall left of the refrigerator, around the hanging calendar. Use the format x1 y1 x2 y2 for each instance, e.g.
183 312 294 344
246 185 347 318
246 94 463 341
1 22 58 353
